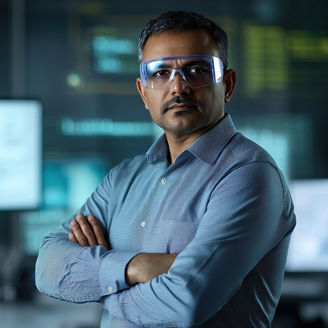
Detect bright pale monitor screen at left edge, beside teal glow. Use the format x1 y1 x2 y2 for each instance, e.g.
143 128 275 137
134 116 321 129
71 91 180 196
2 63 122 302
0 99 42 210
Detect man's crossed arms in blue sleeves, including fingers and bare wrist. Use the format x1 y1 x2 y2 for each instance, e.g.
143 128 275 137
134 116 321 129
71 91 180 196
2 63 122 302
36 163 293 327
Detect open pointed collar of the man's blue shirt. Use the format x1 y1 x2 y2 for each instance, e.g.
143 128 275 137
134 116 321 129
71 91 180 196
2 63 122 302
146 114 236 164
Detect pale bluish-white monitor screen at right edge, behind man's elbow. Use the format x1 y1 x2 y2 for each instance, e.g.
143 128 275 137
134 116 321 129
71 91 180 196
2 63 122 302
286 179 328 272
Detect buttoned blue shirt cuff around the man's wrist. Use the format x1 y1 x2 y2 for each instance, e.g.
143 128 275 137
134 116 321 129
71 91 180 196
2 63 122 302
99 251 138 296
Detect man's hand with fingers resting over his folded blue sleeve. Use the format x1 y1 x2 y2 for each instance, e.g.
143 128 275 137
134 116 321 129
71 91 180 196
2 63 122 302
68 213 109 250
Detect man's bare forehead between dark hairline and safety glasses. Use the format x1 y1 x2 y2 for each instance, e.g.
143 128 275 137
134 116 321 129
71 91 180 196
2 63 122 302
142 30 219 61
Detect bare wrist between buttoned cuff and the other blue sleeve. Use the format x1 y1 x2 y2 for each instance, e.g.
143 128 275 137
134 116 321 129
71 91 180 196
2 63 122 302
125 253 178 286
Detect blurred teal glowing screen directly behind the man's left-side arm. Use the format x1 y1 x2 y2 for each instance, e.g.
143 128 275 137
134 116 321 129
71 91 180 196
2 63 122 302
19 156 109 255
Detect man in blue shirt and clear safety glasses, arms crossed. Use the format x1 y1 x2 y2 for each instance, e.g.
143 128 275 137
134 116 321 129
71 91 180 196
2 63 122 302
36 12 295 328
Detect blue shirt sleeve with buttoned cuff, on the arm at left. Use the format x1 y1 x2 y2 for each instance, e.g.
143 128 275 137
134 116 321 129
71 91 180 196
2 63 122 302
36 174 137 303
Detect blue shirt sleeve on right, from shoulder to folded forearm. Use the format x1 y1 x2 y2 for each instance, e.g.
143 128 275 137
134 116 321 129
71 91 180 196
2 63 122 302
103 162 295 327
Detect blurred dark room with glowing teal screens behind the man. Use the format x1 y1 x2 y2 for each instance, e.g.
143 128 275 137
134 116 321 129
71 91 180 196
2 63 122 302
0 0 328 328
